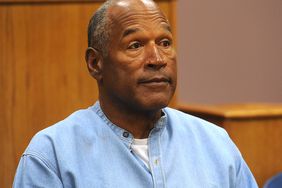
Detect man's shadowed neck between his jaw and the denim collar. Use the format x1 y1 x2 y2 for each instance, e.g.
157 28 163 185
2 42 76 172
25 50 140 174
99 97 161 138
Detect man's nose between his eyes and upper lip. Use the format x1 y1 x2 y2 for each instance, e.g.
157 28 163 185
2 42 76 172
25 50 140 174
146 44 166 70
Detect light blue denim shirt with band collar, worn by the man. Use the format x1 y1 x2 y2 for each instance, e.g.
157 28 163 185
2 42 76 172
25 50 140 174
13 102 257 188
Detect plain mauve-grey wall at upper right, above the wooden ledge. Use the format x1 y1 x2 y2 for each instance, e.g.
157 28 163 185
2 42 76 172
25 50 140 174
177 0 282 104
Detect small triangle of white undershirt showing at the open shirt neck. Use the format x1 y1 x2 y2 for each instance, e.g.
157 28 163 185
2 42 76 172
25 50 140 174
131 138 150 169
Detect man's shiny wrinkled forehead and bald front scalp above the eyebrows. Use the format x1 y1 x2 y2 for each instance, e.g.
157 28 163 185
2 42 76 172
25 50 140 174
108 0 169 29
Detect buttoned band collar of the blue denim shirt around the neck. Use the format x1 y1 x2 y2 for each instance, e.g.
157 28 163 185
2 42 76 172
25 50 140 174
93 101 167 148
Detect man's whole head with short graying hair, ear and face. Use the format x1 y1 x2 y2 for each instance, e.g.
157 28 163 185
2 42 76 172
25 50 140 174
86 0 176 111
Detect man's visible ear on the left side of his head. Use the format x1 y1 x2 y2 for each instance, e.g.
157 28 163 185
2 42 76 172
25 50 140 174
85 47 103 82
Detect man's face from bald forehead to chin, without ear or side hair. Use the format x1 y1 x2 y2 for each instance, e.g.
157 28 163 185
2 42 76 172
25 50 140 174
100 0 177 111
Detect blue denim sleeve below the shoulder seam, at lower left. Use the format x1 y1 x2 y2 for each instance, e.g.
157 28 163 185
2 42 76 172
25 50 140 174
13 154 63 188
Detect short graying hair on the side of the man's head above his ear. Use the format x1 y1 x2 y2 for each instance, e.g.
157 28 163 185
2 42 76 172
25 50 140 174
88 0 113 56
